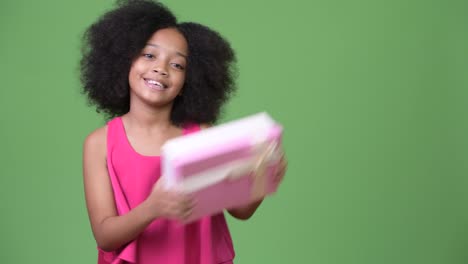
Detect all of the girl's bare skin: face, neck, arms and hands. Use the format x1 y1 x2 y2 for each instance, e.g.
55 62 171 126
83 28 286 251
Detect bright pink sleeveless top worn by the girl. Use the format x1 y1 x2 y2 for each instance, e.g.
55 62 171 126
98 117 234 264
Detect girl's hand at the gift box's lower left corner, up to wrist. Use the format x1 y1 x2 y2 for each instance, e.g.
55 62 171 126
147 177 195 221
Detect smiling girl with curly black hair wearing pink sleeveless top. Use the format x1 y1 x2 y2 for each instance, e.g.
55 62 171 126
81 0 286 264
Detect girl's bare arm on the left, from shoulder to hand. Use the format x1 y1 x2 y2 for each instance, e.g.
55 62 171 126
83 127 192 251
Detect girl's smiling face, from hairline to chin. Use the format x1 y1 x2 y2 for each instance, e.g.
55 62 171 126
128 28 188 106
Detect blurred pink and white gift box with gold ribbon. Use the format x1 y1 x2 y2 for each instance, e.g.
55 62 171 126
162 113 282 222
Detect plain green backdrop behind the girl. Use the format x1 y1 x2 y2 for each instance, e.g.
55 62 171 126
0 0 468 264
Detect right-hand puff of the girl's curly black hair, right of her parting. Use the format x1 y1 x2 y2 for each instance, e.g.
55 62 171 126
171 22 237 123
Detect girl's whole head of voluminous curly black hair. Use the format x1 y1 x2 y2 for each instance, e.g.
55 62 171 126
80 0 237 125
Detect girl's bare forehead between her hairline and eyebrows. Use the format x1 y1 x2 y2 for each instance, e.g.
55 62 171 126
147 28 188 56
